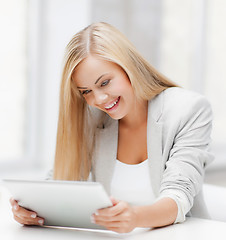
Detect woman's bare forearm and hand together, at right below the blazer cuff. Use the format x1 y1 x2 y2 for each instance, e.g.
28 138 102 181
92 198 177 233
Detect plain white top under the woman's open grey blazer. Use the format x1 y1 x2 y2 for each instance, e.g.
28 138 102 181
111 160 155 205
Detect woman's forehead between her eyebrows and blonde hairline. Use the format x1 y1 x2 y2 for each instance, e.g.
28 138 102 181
72 56 120 86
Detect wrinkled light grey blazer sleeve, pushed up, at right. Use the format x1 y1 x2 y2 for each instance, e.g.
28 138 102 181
157 96 213 223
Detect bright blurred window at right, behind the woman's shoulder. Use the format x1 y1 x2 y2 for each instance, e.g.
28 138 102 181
159 0 226 166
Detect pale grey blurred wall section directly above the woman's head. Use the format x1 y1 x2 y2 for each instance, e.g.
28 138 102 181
92 0 162 67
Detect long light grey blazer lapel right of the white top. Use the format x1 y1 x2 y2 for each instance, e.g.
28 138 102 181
147 94 163 197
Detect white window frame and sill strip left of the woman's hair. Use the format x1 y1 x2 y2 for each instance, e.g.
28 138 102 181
0 0 91 176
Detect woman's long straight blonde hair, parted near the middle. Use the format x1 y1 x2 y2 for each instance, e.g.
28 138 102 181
54 22 176 180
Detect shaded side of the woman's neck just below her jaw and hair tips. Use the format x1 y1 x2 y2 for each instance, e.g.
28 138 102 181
119 101 148 129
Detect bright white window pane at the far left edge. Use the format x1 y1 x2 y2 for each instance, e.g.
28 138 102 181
0 0 27 163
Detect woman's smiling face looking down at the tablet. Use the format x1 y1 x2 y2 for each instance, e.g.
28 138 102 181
72 56 136 119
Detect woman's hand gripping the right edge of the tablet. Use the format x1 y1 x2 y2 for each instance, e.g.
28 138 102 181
92 198 137 233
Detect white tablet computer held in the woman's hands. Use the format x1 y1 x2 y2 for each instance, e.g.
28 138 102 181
3 179 112 229
